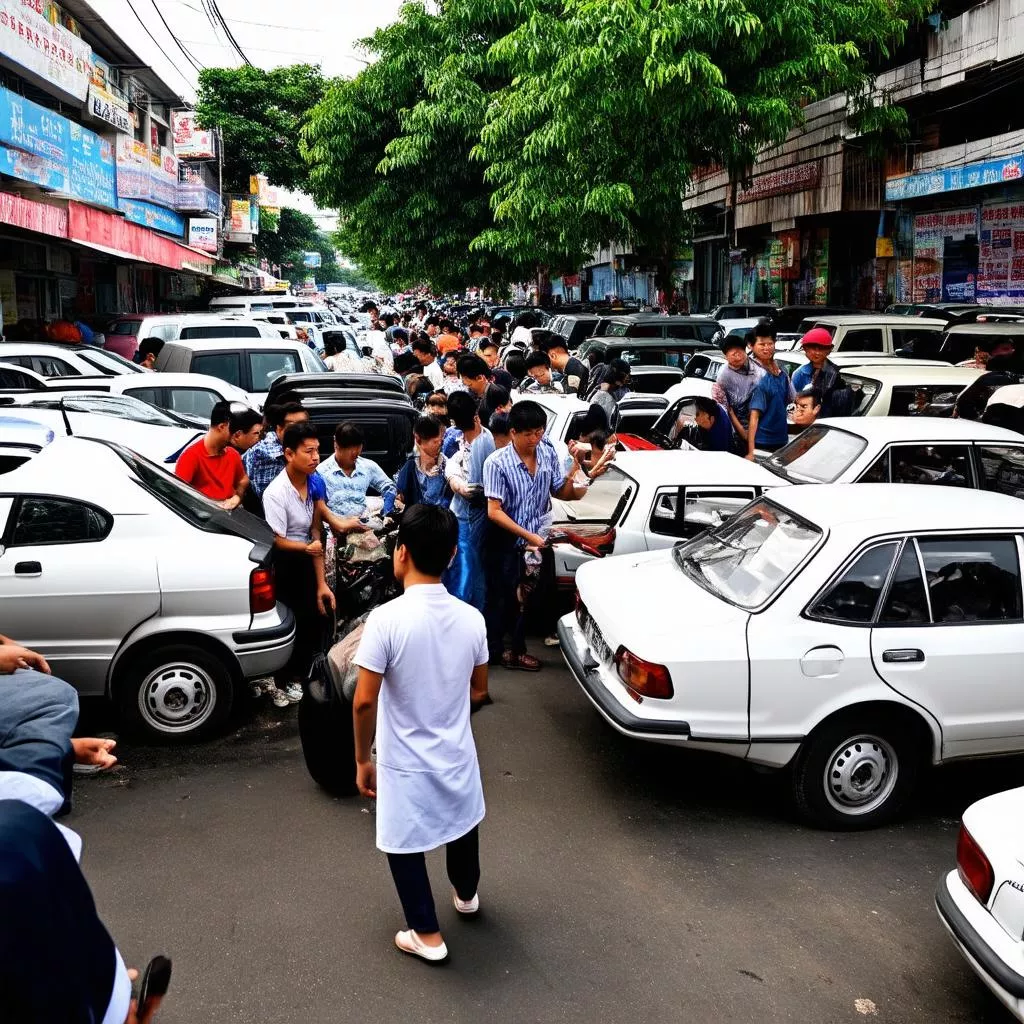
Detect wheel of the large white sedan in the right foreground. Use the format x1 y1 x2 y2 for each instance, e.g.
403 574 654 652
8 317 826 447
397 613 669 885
791 713 923 830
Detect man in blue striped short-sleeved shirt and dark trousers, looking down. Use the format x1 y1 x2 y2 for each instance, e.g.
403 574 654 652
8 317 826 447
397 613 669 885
483 400 587 672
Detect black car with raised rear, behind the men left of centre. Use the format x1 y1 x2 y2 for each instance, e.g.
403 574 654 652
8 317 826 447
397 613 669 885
267 373 420 476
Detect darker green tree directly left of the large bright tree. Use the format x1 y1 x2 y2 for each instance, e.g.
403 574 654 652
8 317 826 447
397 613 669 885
303 0 536 291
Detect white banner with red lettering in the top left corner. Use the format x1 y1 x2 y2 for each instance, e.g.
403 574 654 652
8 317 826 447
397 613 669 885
0 0 92 103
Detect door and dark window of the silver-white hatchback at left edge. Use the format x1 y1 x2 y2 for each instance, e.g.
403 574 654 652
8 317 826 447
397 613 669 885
0 495 160 694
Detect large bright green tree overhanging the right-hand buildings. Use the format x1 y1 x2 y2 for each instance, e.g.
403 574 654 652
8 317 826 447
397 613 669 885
475 0 930 286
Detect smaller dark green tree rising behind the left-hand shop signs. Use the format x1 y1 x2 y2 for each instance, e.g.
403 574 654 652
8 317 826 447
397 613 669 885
196 65 327 193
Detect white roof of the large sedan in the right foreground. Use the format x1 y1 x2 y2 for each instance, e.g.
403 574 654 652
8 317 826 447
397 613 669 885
768 483 1021 537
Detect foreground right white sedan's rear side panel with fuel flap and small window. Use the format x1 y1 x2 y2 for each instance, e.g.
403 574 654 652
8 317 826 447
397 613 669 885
746 540 899 742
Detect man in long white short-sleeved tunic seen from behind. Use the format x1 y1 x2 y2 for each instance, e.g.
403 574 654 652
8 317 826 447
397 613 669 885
353 505 489 962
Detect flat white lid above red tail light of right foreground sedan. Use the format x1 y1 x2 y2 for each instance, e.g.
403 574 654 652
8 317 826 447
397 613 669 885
575 549 750 663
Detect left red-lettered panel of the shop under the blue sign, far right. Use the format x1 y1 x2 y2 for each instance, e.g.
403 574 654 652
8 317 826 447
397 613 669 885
912 206 978 302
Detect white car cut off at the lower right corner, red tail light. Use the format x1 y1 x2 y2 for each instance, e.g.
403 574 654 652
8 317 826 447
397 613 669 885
935 788 1024 1021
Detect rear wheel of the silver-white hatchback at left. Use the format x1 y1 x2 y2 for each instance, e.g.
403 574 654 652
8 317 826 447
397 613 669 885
120 644 233 742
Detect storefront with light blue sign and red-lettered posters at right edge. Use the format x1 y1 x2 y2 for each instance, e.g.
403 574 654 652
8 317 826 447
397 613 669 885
886 155 1024 305
